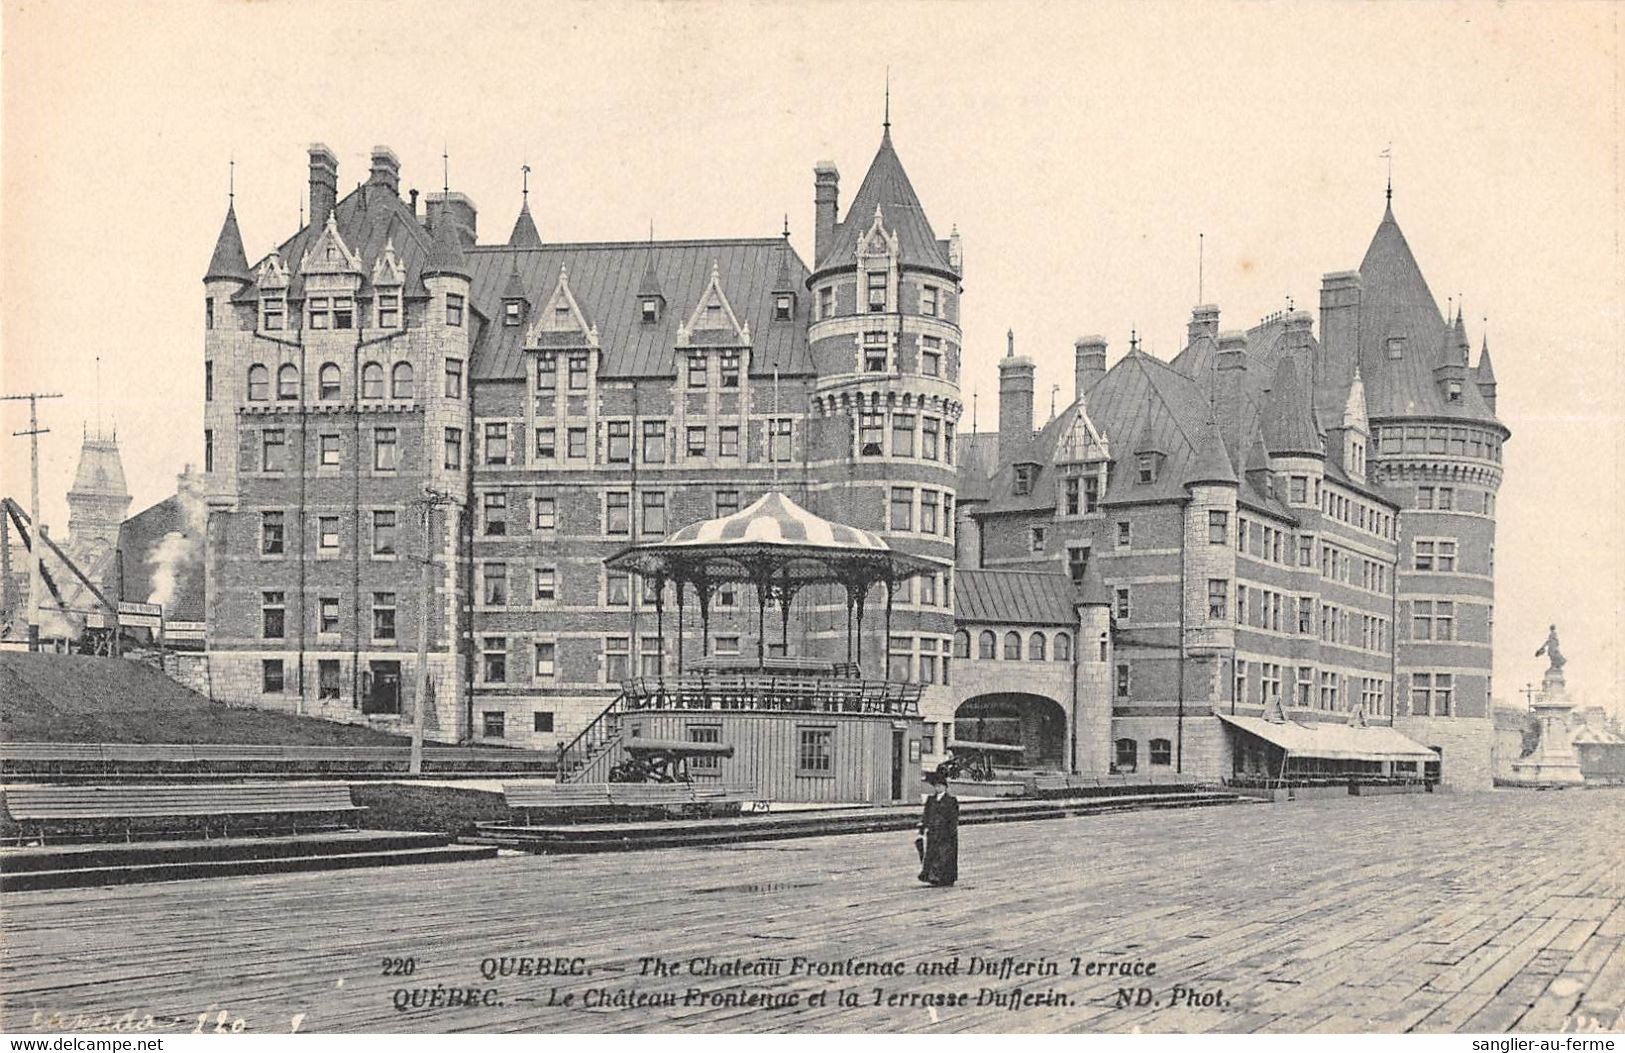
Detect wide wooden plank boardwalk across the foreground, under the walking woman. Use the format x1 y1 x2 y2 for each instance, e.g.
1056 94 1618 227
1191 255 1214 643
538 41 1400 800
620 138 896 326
0 790 1625 1032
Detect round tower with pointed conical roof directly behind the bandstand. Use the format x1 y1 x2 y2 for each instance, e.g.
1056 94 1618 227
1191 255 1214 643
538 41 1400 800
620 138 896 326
808 120 962 668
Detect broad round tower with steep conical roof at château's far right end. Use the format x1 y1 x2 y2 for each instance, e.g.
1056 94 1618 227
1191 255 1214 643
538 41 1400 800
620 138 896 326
1316 202 1511 790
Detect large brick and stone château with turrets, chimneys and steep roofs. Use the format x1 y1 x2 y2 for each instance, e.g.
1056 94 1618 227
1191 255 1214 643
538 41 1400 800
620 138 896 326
203 125 1506 785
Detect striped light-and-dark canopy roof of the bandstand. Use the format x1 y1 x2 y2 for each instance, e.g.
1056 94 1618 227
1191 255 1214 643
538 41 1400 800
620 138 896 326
606 491 947 588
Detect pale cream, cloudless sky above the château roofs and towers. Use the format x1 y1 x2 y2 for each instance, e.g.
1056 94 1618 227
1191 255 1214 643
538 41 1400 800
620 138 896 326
0 0 1625 705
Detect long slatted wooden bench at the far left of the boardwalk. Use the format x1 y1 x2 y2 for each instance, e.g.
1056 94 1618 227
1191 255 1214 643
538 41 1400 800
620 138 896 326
5 783 364 843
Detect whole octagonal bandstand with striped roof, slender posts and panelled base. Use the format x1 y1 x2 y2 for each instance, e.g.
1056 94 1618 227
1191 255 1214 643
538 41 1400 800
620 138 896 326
559 492 946 803
